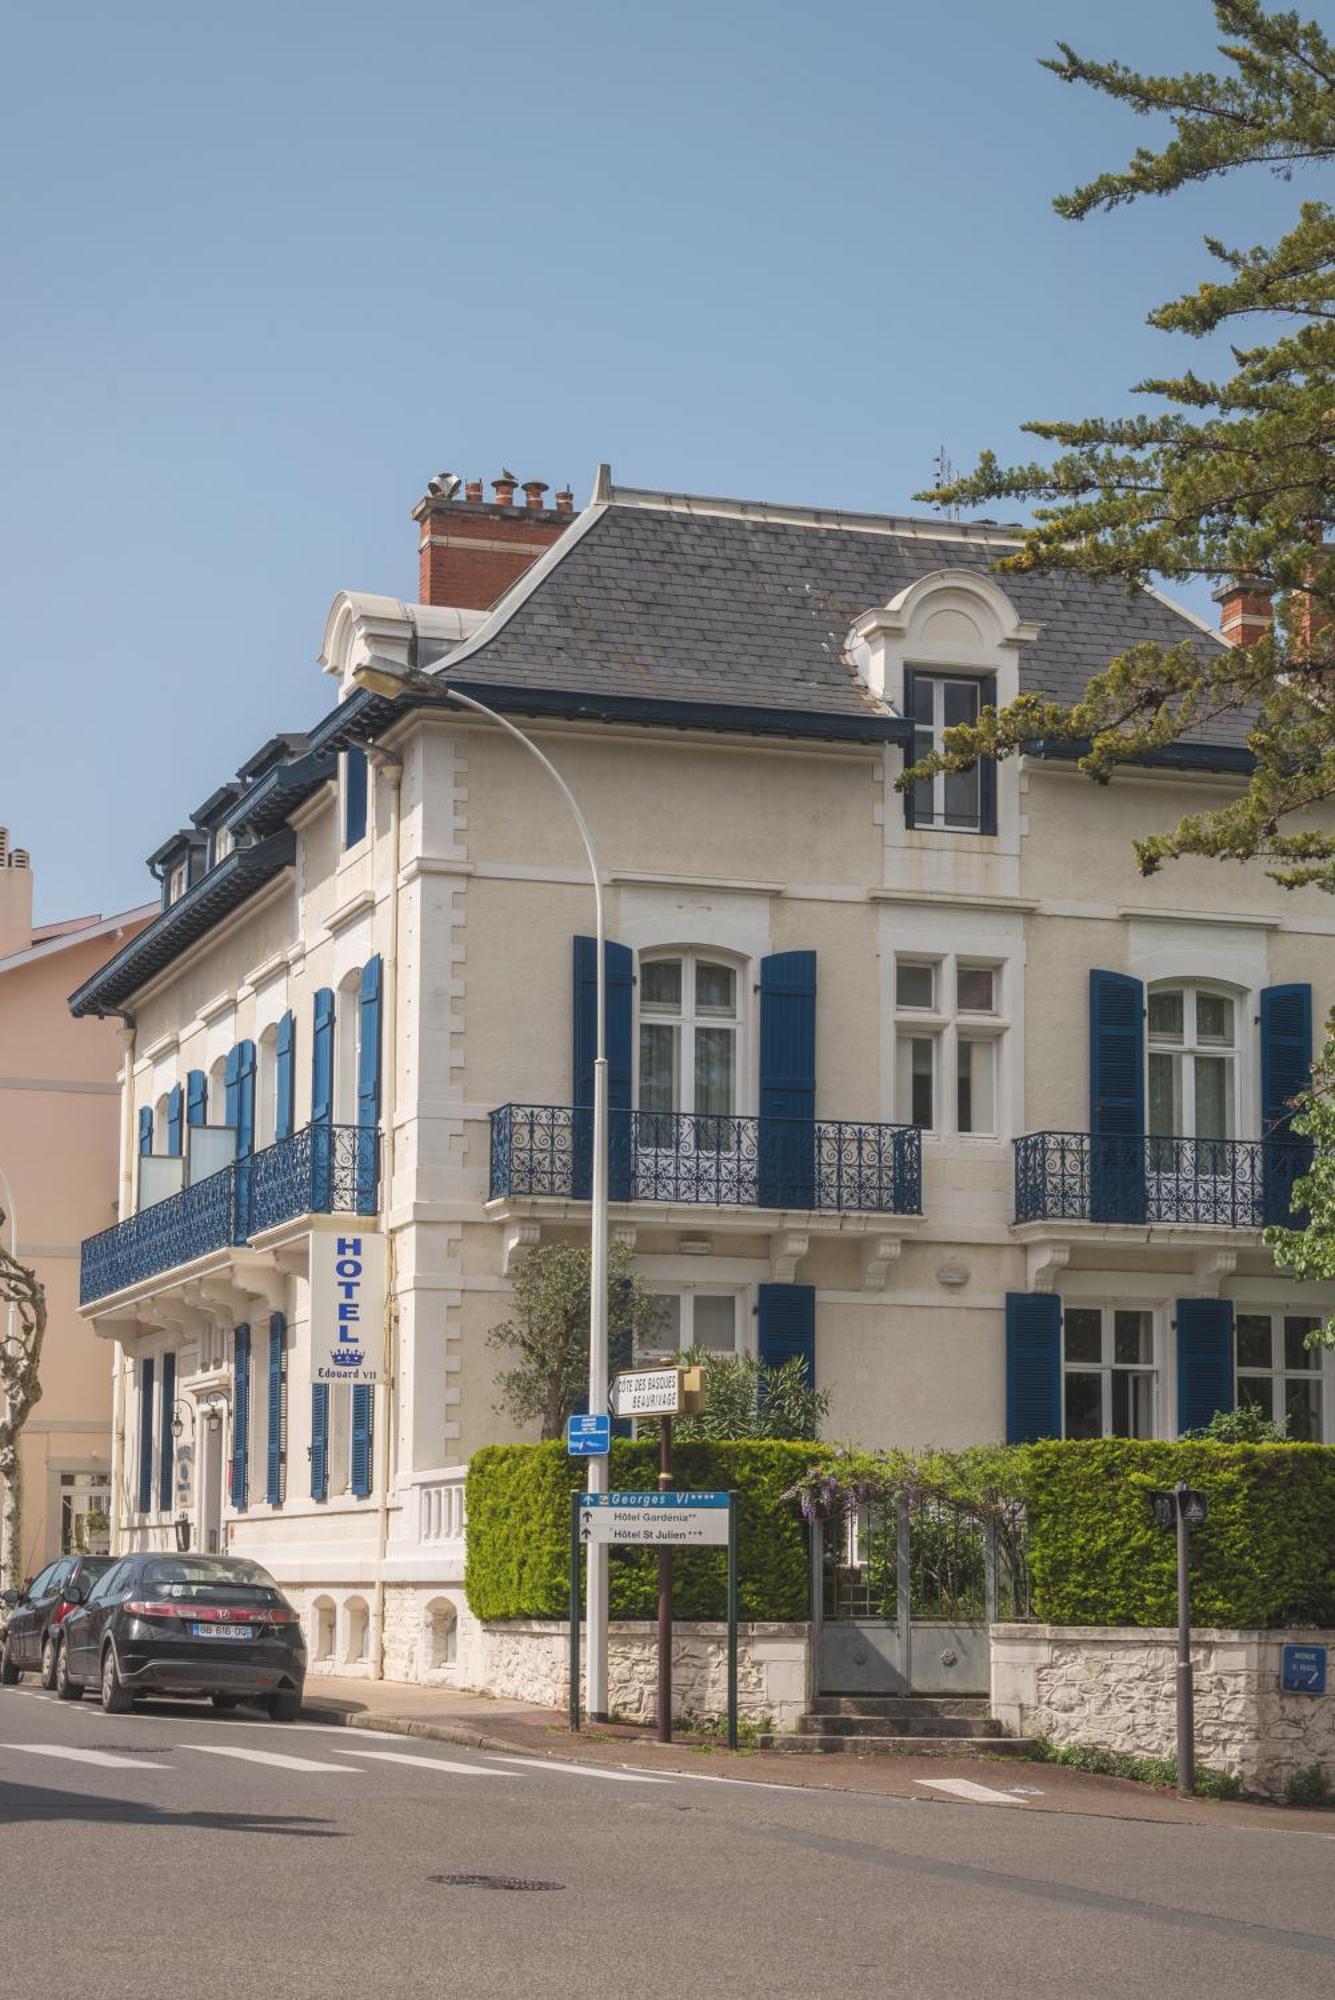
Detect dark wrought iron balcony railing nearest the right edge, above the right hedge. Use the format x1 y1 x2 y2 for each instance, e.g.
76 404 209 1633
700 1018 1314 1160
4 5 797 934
1015 1132 1311 1230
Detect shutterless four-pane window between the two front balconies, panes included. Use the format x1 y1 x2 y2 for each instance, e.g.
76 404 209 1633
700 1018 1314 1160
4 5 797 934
895 958 1005 1134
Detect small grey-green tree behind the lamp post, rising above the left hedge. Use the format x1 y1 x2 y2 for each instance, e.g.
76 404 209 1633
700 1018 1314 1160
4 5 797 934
488 1242 664 1438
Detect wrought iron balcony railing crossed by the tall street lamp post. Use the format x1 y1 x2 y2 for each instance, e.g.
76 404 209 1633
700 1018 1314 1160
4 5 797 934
492 1104 923 1216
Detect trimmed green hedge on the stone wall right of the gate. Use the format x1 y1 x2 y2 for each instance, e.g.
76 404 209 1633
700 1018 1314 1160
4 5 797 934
1025 1438 1335 1626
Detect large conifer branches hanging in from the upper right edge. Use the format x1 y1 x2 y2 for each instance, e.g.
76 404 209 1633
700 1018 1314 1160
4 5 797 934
901 0 1335 890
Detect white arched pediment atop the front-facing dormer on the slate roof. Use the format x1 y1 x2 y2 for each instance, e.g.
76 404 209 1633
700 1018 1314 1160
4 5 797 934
847 568 1041 708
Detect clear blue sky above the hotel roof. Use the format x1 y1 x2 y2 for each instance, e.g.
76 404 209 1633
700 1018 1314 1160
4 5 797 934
0 0 1295 918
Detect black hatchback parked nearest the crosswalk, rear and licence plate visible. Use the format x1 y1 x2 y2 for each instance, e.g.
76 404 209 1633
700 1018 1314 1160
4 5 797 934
56 1554 306 1722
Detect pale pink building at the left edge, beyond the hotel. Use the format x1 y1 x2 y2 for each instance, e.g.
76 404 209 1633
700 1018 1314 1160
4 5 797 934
0 826 152 1576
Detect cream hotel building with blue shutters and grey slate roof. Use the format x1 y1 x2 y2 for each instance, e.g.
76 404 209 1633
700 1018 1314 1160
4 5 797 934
72 468 1335 1678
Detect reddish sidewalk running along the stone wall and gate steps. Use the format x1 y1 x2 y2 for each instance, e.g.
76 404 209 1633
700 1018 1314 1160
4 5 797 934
302 1674 1335 1842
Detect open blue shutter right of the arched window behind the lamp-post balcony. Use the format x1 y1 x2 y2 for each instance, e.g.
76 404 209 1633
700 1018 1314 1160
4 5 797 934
757 952 815 1208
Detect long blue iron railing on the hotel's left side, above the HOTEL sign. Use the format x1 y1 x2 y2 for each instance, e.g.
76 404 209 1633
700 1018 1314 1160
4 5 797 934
80 1126 380 1306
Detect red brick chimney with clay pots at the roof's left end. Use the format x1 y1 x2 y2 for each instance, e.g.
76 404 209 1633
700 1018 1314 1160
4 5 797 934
412 472 574 610
